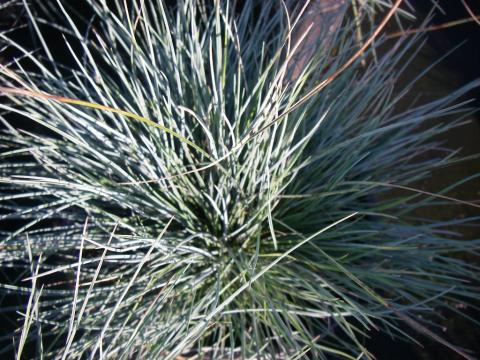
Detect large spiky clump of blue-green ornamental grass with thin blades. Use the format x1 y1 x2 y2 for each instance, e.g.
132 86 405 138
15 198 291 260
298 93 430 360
0 0 479 359
